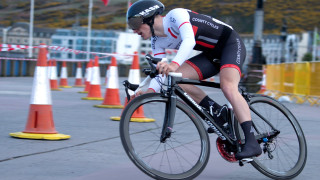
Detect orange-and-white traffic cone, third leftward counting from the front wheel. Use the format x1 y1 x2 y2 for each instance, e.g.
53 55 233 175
81 56 103 100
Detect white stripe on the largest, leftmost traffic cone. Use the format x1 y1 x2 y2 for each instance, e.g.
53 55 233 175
30 66 51 105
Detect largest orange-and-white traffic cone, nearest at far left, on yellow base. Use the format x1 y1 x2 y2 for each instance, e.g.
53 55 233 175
10 44 70 140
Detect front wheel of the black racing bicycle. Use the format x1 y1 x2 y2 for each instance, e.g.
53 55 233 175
120 93 210 179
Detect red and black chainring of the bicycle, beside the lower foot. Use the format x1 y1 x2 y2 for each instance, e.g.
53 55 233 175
216 137 238 162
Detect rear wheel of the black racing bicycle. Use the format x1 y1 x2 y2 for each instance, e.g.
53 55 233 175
235 95 307 179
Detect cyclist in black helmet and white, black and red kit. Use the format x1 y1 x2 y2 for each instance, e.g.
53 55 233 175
127 0 262 160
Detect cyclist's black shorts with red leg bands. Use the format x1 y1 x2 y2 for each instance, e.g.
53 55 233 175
186 31 246 80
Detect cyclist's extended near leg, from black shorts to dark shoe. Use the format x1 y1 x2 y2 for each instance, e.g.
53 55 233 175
220 32 262 159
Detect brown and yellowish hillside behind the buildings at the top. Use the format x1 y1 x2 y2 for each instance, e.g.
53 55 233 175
0 0 320 34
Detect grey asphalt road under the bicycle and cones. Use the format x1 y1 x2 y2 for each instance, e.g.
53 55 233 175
0 77 320 180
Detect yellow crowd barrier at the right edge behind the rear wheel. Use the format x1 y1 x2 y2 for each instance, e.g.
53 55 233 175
266 62 320 105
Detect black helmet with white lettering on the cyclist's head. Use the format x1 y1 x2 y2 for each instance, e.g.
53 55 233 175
127 0 164 29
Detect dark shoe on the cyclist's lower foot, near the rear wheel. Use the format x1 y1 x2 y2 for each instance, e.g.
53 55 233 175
235 143 262 160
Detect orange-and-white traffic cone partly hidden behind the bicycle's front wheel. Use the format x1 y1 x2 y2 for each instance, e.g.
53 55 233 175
110 53 155 122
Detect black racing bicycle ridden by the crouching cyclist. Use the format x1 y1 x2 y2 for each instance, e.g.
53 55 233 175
120 55 307 180
